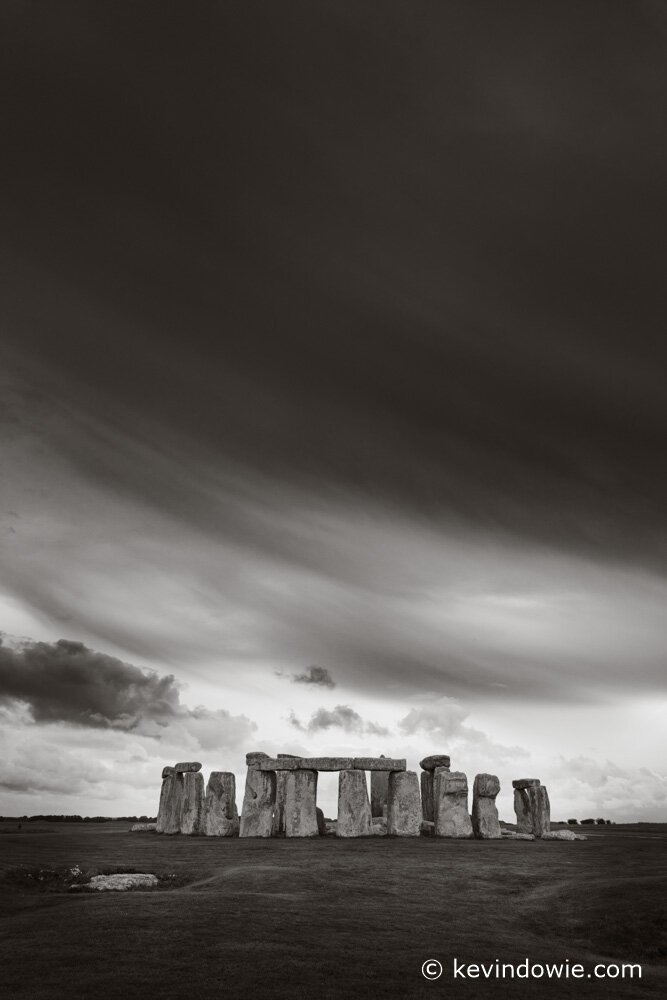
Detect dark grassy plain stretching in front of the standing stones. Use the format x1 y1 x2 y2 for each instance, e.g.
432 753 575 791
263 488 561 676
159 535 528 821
0 823 667 1000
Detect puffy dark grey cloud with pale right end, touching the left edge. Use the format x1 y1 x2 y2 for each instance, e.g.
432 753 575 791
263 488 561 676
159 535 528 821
0 639 257 748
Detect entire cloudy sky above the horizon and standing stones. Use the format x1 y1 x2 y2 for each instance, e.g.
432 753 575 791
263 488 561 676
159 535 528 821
0 0 667 820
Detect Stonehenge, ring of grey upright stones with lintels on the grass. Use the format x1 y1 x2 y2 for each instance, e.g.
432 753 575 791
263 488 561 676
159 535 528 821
154 751 564 840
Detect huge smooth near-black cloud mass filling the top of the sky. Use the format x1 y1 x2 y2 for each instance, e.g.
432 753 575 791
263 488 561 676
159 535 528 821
0 0 667 580
